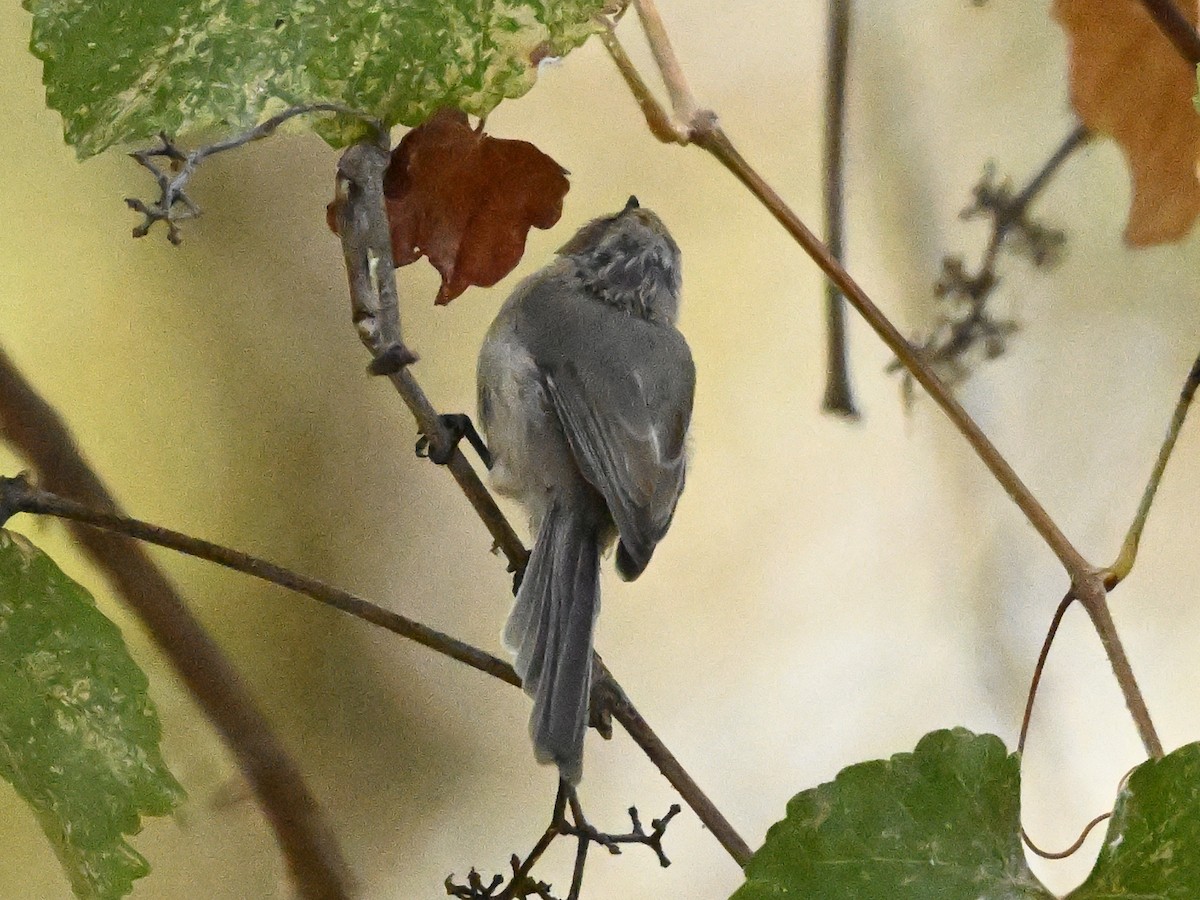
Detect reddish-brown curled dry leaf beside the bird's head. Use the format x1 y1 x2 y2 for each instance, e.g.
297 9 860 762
384 109 570 305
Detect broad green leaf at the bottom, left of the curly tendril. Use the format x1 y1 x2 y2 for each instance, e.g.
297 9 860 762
733 728 1054 900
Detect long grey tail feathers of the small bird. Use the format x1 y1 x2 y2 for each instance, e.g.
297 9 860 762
504 503 600 784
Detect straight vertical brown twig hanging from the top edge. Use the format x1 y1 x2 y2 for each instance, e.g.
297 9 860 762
821 0 858 419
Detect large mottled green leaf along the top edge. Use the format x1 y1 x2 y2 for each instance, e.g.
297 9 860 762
24 0 606 157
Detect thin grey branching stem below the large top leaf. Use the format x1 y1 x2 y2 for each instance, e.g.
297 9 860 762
125 103 386 245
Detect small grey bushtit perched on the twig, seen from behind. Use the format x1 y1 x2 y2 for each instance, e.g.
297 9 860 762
479 197 696 784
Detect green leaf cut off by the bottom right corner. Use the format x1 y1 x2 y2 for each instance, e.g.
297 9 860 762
1070 744 1200 900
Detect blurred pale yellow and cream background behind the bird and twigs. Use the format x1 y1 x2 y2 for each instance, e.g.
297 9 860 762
0 0 1200 900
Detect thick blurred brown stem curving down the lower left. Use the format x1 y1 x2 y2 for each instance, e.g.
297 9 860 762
0 350 353 900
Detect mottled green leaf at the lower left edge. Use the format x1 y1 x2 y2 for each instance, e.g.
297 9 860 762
0 529 184 898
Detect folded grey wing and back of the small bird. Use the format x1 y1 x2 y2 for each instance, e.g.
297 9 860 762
517 283 696 578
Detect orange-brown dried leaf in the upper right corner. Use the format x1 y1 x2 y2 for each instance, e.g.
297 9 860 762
1054 0 1200 247
